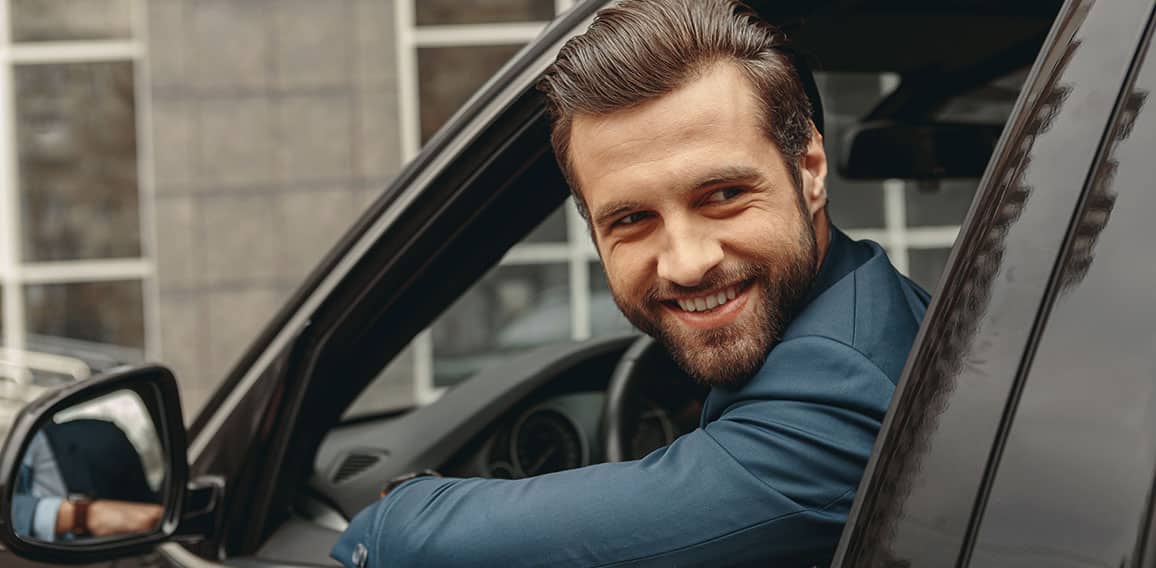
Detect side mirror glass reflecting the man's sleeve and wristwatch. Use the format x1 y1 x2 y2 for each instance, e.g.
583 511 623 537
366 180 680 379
10 390 168 545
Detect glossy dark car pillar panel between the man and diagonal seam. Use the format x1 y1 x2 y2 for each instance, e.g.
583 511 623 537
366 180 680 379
836 0 1151 567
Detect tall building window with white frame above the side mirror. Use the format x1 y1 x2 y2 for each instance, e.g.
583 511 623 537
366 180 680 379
0 0 157 381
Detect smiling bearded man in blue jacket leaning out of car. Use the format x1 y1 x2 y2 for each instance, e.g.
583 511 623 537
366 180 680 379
333 0 927 567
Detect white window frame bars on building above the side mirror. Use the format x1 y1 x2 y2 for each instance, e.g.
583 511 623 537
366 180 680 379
0 0 160 379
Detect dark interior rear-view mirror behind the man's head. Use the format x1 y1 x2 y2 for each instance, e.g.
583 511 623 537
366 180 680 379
839 121 1003 180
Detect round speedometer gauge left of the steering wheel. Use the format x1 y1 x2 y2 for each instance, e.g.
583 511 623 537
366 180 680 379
510 410 583 477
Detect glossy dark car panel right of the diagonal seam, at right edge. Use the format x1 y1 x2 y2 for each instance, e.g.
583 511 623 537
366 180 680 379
971 15 1156 567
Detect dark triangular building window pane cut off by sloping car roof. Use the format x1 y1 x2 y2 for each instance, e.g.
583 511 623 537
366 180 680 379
417 45 521 141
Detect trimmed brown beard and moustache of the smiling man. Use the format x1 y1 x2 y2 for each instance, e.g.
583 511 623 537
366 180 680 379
612 216 818 389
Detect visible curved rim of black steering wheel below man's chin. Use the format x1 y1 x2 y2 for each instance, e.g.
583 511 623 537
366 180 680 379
601 335 680 462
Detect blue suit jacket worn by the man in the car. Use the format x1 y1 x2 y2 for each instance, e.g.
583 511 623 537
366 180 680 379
332 229 927 568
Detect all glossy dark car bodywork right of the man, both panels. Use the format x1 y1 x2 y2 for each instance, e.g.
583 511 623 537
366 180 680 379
836 1 1156 566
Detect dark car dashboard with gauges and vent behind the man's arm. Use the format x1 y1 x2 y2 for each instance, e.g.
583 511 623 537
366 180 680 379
307 335 706 518
